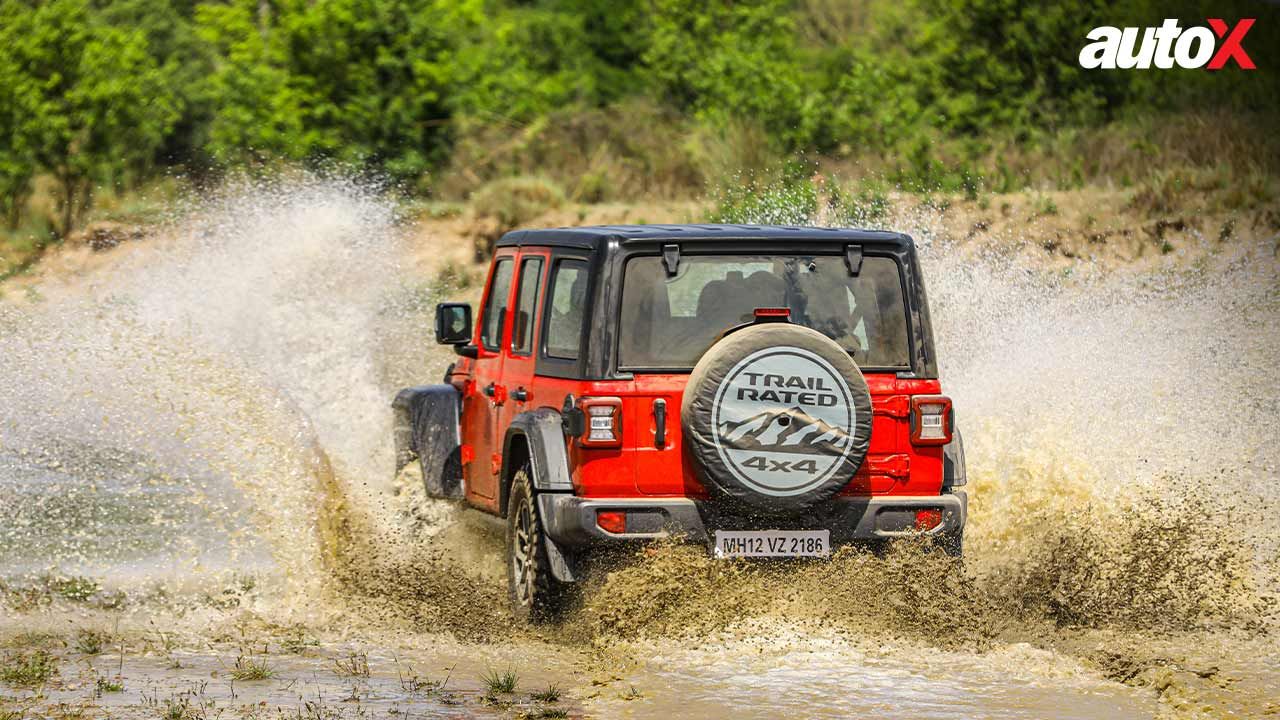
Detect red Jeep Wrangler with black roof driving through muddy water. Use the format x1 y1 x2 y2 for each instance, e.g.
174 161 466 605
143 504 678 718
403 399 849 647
393 225 966 620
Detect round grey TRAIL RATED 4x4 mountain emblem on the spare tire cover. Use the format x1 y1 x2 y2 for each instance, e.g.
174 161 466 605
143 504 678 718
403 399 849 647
712 347 856 497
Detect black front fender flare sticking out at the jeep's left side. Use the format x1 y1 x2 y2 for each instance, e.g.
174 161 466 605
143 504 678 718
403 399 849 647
392 384 462 498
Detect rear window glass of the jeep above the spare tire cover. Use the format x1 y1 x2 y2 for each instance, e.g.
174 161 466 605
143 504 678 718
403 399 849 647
618 255 911 369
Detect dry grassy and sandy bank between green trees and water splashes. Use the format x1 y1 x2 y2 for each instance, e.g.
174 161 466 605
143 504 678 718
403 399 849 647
0 109 1280 278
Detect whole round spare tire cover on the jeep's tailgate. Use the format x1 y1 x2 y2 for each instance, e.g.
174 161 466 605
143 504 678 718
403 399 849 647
681 323 872 512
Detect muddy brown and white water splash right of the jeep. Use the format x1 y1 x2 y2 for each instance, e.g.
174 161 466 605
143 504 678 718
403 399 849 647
925 230 1280 628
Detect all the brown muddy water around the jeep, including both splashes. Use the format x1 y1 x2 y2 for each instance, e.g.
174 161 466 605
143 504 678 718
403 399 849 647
0 179 1280 720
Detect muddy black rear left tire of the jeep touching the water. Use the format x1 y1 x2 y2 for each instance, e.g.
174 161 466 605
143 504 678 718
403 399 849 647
507 469 568 623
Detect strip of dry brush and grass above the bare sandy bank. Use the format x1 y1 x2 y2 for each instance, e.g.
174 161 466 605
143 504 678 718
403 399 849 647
431 109 1280 209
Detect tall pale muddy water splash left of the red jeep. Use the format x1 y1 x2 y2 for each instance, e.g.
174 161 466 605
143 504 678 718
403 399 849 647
0 178 455 607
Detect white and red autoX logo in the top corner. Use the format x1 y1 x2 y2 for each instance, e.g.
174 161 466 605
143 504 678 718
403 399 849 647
1080 18 1257 70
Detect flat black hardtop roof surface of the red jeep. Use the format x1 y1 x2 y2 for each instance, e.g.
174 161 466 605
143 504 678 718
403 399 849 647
497 224 911 250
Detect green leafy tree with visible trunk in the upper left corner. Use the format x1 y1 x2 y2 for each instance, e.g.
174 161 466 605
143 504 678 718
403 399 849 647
0 0 175 237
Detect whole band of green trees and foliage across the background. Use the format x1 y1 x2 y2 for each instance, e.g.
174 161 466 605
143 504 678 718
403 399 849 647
0 0 1280 237
